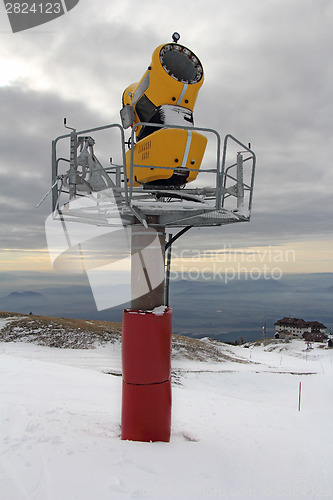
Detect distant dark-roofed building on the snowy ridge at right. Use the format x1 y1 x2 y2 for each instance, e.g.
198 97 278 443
274 318 327 342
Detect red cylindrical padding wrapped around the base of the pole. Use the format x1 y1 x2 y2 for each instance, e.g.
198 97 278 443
121 308 172 442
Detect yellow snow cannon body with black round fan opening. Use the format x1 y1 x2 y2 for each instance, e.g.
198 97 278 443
120 43 207 189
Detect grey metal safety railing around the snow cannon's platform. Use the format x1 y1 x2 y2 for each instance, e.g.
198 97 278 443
51 122 256 221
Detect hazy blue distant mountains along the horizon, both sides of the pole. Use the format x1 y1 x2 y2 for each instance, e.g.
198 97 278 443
0 273 333 341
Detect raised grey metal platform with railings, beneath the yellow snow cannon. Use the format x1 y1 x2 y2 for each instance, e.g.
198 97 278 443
51 122 256 228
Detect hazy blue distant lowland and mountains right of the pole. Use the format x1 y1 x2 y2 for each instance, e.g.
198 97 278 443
170 274 333 341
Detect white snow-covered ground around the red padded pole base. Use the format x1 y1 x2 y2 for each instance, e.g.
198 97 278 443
0 318 333 500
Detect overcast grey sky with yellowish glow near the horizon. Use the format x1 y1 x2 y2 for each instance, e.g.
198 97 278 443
0 0 333 272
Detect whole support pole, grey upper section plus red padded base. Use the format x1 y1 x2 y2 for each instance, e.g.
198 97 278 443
121 224 172 442
